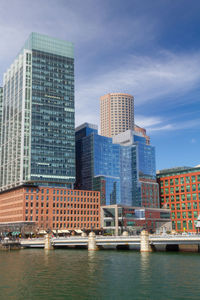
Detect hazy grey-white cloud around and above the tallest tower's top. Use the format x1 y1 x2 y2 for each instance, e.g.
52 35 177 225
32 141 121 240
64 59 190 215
0 0 157 81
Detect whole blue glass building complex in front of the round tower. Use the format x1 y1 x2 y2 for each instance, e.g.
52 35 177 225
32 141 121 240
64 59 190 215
76 123 159 207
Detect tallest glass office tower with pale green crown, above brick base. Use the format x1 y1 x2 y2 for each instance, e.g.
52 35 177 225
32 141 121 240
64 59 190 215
0 33 75 190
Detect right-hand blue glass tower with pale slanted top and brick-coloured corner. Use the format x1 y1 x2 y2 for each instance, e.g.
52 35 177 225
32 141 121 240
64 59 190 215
113 130 159 208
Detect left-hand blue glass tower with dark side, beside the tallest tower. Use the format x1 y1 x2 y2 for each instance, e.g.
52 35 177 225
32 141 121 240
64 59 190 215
76 123 121 204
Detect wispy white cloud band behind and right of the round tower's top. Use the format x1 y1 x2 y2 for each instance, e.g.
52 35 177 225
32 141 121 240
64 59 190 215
76 52 200 126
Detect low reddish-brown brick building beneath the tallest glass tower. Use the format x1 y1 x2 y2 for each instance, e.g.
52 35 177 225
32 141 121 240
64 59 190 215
0 185 100 231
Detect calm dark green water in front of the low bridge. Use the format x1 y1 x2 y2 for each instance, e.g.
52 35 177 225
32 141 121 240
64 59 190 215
0 249 200 300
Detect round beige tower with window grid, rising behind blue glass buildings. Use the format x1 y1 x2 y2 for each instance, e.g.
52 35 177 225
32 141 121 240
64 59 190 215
100 93 134 137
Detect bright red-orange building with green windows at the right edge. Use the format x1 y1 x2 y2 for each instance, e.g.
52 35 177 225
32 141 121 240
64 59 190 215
157 166 200 232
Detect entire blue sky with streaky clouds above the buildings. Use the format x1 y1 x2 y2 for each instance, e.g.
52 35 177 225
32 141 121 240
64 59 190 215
0 0 200 169
